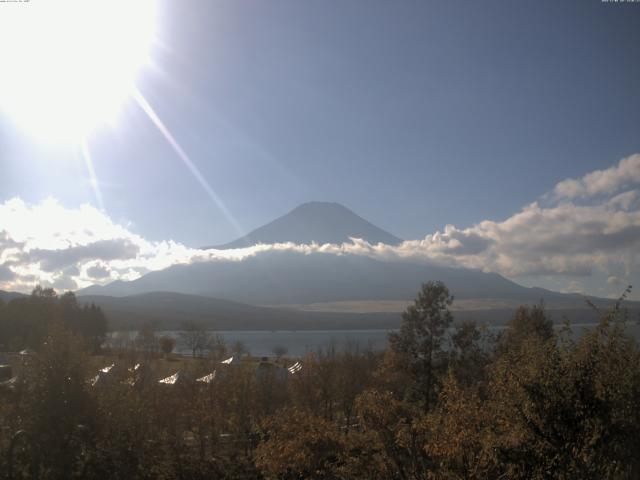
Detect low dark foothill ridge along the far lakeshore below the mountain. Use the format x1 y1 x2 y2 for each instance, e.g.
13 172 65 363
78 292 640 331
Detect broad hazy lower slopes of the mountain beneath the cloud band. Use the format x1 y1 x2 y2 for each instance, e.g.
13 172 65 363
79 251 600 305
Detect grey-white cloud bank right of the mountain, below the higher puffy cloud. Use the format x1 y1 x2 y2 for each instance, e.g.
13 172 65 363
390 197 640 277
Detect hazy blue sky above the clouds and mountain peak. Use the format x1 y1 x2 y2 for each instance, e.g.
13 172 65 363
0 0 640 296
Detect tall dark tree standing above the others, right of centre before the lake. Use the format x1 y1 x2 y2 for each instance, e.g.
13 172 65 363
389 281 453 411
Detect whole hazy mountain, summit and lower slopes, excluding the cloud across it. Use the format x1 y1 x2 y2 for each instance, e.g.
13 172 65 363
78 202 632 316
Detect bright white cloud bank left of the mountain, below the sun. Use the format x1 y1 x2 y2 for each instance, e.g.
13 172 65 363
0 198 260 290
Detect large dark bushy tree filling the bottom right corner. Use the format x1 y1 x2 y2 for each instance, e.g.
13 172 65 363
486 286 640 479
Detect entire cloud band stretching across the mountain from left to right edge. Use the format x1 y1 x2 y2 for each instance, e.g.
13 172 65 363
0 154 640 295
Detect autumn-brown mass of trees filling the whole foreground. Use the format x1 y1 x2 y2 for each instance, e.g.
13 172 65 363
0 282 640 480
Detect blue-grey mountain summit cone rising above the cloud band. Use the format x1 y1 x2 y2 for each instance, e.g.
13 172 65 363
205 202 402 249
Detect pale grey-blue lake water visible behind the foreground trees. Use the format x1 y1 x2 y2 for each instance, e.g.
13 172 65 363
112 323 640 357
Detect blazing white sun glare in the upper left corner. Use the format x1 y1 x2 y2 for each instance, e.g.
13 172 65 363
0 0 157 140
